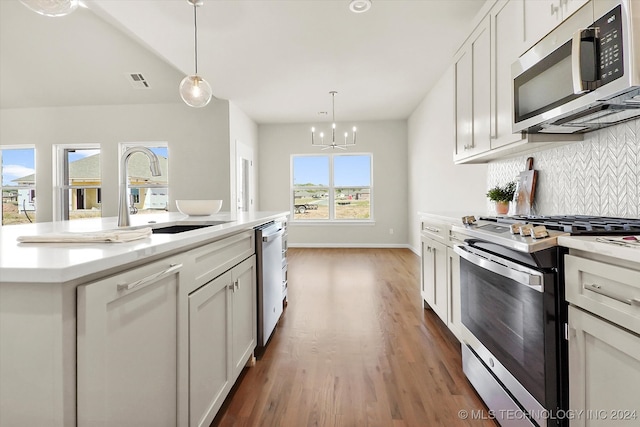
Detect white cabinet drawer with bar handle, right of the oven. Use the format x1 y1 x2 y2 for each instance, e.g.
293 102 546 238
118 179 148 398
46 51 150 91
565 255 640 334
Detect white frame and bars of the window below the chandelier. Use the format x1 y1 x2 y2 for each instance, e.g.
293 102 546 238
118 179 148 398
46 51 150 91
289 152 375 225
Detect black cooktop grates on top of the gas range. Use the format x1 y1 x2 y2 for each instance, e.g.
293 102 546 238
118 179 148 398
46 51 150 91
480 215 640 235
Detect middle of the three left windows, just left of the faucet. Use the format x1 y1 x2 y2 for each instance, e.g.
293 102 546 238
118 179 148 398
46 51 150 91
54 144 102 220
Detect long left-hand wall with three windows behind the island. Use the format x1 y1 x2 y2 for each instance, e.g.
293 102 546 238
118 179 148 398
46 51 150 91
0 100 230 222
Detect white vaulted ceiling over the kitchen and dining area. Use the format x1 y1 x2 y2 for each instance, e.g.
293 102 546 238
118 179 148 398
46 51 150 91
0 0 484 123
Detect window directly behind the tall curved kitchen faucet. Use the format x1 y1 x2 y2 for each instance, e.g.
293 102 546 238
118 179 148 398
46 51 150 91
120 142 169 213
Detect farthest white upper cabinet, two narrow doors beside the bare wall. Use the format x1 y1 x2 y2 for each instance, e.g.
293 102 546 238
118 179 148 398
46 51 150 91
454 16 491 160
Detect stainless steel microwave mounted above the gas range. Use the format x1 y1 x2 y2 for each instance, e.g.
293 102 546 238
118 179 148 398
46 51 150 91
511 0 640 134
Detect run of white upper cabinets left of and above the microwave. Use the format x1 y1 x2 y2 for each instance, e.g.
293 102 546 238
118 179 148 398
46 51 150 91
453 0 589 163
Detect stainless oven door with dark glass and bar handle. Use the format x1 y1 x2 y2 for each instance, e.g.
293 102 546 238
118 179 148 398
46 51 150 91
455 246 556 409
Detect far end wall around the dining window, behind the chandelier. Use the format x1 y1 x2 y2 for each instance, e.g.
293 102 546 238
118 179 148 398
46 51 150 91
258 120 408 247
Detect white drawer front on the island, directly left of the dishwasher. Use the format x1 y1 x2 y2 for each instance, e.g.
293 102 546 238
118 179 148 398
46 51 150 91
188 230 255 287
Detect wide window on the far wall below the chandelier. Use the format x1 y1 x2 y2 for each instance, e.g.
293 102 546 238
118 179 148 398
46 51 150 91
291 154 373 221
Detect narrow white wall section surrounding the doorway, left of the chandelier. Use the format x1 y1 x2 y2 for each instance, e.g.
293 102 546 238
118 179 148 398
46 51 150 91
229 102 260 211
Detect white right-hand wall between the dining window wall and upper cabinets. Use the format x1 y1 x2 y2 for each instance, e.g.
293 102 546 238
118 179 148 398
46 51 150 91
408 67 487 252
